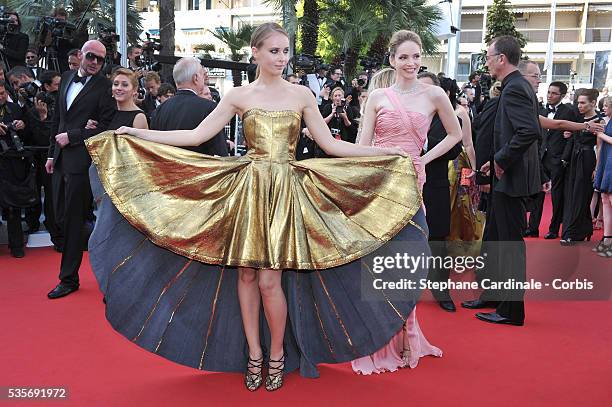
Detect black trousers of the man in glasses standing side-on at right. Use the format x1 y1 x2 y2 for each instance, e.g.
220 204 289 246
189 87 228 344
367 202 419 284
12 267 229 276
487 191 527 322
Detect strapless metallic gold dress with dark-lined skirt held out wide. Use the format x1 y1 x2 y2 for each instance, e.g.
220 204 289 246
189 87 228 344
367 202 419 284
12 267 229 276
86 109 436 377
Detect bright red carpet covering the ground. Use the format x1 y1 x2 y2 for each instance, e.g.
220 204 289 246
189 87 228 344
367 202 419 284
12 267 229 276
0 196 612 407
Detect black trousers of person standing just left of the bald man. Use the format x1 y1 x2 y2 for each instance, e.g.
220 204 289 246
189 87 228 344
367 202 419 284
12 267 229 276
25 153 63 242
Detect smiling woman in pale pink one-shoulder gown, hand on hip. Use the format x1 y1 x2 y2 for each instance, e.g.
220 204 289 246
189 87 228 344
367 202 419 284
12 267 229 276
352 30 461 374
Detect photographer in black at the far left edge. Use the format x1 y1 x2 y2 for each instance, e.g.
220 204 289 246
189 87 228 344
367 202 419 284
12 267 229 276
0 81 30 258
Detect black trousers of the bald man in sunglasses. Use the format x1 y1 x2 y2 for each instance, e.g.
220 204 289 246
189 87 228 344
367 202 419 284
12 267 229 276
53 168 93 287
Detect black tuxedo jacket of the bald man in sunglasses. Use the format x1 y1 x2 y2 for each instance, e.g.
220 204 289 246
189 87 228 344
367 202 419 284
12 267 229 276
49 71 117 174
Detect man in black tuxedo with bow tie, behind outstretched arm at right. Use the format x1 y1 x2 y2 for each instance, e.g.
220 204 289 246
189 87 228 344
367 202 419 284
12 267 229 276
542 82 579 239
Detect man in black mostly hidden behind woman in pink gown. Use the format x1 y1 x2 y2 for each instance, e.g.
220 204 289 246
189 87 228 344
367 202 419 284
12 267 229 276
418 72 462 312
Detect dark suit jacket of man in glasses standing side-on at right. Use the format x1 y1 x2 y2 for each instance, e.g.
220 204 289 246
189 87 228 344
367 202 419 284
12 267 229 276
491 70 542 197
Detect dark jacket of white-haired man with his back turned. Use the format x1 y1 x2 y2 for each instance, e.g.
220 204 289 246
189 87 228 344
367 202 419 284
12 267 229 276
151 90 227 157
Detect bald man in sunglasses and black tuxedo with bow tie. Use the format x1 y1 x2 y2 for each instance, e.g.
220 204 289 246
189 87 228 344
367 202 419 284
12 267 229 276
45 40 116 299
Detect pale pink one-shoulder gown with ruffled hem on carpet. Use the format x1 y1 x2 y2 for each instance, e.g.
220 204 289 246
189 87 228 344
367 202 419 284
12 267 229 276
351 88 442 375
